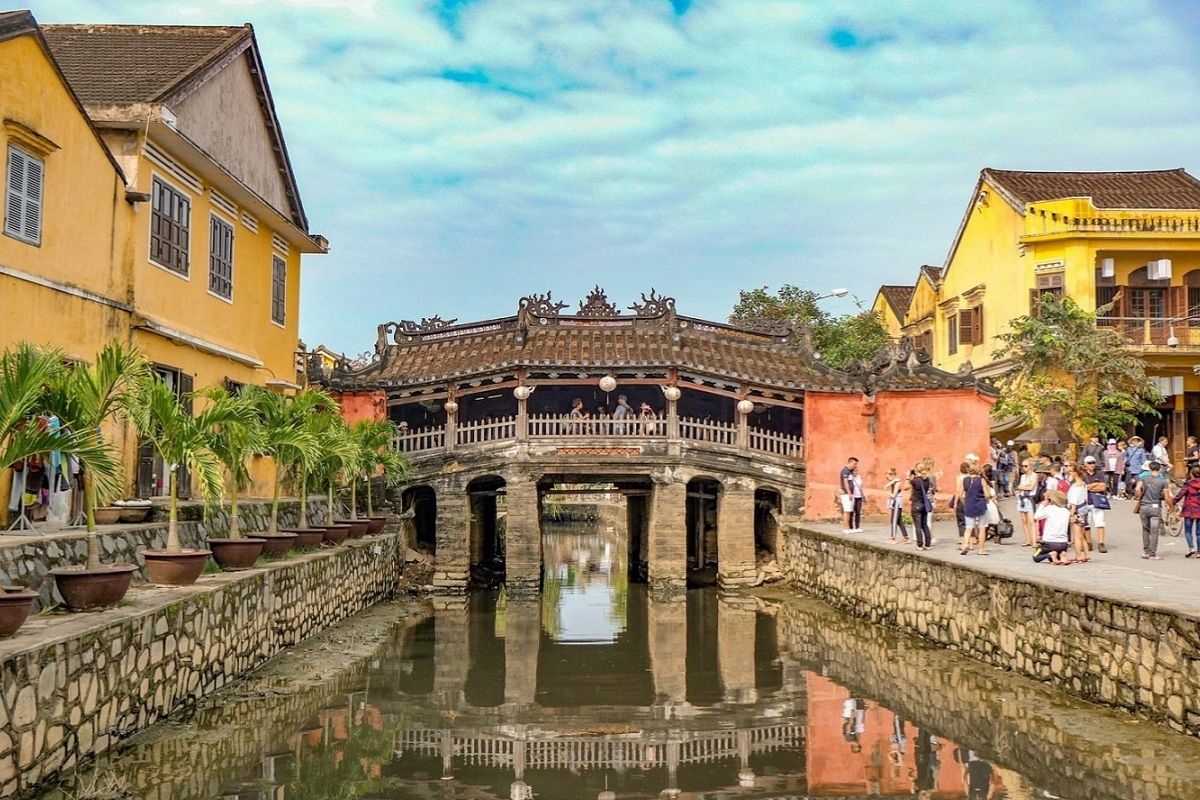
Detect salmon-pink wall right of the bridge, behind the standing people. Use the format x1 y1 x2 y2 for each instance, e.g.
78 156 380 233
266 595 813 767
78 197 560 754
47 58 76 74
804 389 995 519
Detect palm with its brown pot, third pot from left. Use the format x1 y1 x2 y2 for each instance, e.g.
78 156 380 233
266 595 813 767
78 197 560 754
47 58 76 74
131 377 235 587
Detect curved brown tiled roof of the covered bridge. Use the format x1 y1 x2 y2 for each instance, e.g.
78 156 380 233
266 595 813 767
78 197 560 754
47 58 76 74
358 320 848 389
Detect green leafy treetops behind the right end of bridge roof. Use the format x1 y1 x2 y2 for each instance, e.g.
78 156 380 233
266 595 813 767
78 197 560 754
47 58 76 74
730 284 890 369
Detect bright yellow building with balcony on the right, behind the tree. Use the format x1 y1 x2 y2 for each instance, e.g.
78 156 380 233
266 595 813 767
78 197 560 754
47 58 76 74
888 169 1200 462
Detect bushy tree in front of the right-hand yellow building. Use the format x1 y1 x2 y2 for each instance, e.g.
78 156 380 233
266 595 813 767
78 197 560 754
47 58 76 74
992 294 1163 435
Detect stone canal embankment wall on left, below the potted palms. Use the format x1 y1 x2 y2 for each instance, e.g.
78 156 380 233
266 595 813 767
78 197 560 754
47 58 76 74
0 534 403 798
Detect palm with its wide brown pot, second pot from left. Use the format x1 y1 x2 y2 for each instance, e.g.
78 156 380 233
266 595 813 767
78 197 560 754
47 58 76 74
48 342 150 610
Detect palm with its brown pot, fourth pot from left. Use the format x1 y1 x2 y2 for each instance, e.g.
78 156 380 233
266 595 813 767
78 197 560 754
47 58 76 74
199 386 266 572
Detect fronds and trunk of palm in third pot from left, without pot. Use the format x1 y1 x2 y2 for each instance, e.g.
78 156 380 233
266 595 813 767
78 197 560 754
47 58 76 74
130 375 229 553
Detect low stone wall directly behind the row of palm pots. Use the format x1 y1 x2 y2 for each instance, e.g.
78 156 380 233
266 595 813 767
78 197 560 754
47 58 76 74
0 498 326 607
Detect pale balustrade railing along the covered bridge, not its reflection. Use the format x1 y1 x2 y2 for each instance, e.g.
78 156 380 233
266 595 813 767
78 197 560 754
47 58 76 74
391 415 804 459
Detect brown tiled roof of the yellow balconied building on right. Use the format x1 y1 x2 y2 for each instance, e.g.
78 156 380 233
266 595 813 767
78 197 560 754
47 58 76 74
983 168 1200 209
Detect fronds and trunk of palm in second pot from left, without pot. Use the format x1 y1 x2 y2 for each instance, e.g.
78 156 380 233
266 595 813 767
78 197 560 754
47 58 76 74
48 341 151 570
